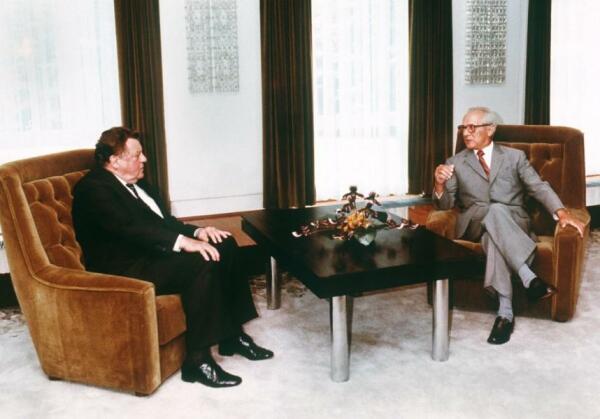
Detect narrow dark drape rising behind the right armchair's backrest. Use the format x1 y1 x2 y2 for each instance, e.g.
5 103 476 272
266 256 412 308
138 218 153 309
524 0 552 125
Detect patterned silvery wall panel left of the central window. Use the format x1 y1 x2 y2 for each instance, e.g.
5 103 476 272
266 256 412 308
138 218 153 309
185 0 240 94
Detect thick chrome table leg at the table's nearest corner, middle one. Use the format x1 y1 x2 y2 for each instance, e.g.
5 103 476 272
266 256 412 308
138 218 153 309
329 295 353 382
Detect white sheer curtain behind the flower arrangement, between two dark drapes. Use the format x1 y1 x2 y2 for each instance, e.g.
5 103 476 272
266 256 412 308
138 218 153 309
312 0 408 200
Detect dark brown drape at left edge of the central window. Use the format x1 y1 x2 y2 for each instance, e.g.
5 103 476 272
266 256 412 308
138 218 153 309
260 0 315 208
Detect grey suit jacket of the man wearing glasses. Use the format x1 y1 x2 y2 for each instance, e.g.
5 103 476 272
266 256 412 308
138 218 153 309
433 143 564 238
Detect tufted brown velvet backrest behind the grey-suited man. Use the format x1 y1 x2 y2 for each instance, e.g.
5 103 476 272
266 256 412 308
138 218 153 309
456 125 586 235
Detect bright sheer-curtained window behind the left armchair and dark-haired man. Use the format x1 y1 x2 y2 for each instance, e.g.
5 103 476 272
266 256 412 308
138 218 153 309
0 0 121 163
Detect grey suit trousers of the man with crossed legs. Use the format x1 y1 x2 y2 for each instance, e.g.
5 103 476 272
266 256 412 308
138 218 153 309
463 203 536 298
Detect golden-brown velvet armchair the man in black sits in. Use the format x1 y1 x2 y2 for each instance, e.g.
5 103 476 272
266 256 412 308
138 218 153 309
0 150 186 395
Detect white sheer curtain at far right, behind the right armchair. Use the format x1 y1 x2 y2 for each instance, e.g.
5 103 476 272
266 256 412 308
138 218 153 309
550 0 600 175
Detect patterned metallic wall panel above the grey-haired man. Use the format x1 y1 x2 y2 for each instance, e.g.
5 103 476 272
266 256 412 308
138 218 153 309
465 0 506 84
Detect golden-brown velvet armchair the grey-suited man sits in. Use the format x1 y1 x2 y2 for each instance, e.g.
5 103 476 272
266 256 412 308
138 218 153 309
426 125 590 321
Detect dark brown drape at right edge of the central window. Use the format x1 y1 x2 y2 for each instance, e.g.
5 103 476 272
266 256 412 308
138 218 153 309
408 0 453 194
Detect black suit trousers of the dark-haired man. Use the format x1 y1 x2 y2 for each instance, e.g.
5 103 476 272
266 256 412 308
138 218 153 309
124 237 258 353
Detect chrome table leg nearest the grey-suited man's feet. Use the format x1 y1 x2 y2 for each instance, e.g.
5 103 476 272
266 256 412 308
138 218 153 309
431 279 450 361
